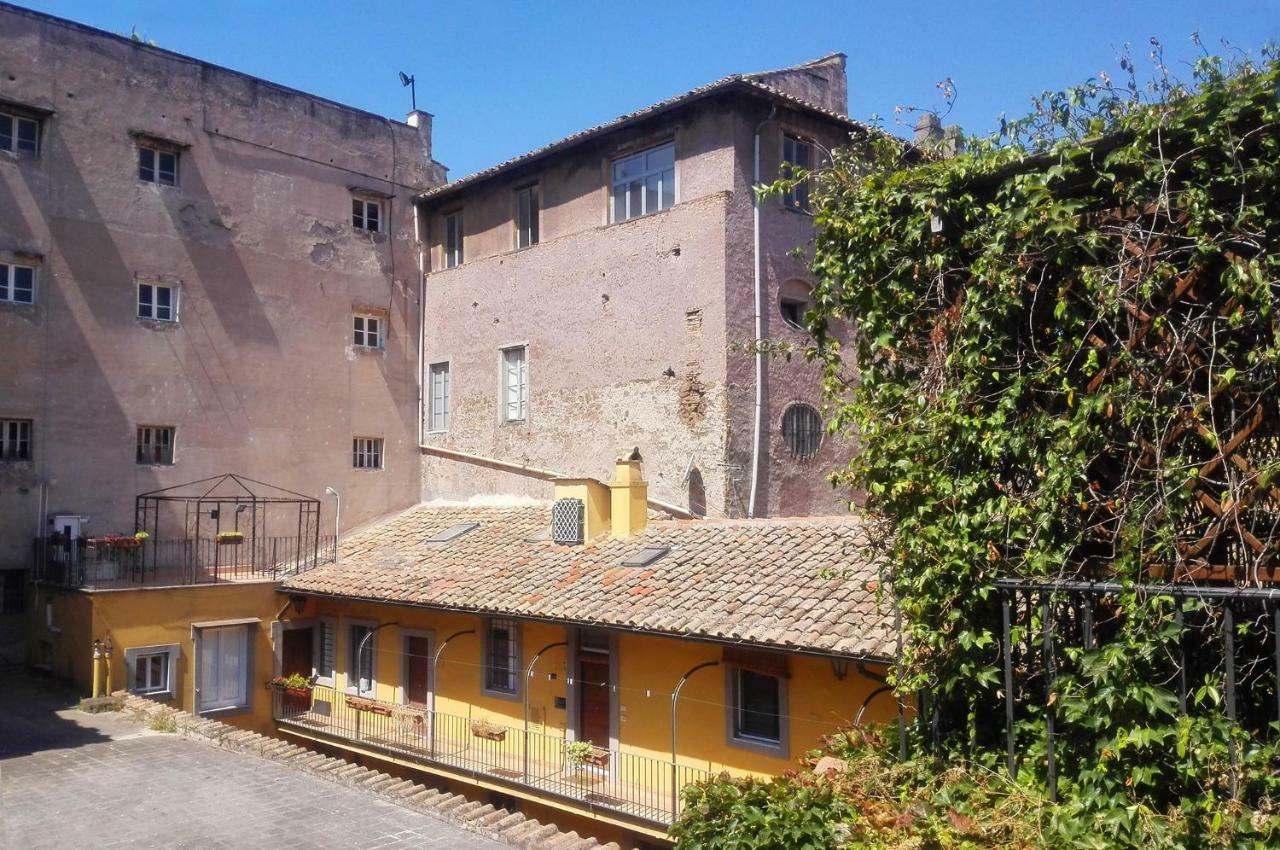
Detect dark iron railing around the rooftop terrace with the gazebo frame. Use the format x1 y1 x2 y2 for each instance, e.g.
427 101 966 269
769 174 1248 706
35 535 334 589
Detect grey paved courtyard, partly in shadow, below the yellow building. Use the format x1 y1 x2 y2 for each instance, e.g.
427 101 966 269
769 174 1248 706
0 675 507 850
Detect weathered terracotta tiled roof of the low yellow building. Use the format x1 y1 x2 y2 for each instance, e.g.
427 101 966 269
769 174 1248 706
284 504 895 659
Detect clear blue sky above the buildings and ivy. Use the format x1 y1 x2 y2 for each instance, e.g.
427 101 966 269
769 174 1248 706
24 0 1280 178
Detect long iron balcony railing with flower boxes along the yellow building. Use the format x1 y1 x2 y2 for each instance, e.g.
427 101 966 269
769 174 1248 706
273 685 712 826
